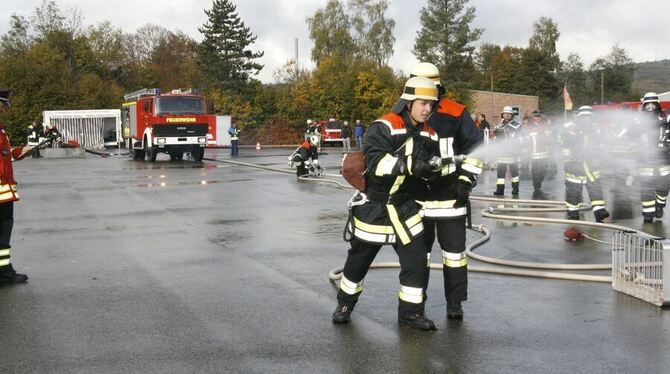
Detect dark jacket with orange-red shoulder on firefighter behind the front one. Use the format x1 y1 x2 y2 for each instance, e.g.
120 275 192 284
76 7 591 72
418 98 483 219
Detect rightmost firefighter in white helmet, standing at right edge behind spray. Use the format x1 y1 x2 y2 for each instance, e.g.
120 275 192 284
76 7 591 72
637 92 670 222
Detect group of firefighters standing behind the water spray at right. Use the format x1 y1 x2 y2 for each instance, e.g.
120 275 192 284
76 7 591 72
491 92 670 222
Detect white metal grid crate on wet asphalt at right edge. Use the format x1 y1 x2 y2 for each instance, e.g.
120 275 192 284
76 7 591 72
612 231 670 306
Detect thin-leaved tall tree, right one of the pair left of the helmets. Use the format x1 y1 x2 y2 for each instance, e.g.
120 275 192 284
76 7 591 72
349 0 395 67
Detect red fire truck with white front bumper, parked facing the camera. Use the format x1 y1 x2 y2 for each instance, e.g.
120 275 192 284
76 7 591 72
121 88 216 162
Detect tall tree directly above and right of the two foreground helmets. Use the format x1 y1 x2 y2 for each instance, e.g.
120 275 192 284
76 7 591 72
413 0 484 97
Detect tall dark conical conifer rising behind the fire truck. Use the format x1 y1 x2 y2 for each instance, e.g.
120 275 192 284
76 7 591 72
198 0 264 88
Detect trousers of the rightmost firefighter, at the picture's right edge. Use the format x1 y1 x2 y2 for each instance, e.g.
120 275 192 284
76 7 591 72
638 165 670 215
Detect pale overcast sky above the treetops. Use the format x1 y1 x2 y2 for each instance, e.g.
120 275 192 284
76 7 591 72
0 0 670 82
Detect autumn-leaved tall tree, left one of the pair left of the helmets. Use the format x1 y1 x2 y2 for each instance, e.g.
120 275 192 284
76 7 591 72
307 0 356 65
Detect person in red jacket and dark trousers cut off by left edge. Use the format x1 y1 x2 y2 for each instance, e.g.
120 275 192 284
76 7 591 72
0 88 32 285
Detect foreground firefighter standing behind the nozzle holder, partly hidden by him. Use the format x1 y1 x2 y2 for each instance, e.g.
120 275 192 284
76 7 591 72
410 62 483 319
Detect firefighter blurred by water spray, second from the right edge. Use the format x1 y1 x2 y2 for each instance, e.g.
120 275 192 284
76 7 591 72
561 105 610 222
